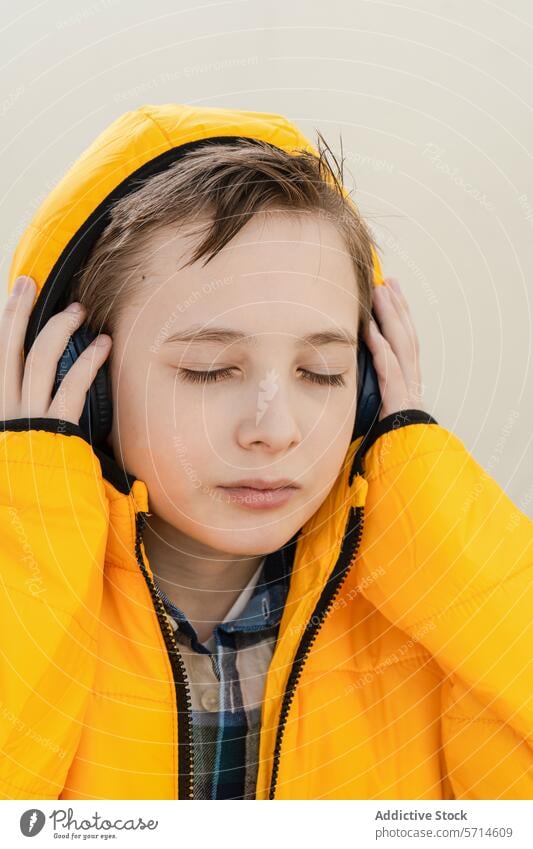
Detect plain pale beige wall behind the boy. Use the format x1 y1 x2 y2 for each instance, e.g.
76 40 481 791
0 0 533 516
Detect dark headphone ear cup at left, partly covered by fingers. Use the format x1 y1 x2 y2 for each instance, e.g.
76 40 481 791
52 324 113 447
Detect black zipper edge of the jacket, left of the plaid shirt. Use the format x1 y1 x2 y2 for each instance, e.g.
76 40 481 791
135 512 194 799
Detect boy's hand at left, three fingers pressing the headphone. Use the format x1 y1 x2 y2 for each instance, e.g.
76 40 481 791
0 277 111 425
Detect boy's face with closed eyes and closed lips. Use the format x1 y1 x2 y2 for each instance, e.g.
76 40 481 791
109 213 358 555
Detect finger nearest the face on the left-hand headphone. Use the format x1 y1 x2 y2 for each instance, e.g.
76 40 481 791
48 334 112 424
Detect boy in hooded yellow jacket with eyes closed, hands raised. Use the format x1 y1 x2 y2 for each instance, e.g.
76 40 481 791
0 104 532 799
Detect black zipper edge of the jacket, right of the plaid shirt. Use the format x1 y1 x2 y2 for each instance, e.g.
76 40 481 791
269 506 364 799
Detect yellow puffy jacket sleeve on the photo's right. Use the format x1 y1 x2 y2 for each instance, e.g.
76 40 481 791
358 411 533 799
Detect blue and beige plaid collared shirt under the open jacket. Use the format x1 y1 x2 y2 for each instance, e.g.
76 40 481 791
154 535 297 799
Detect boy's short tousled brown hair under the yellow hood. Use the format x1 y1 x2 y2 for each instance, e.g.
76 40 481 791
72 131 375 335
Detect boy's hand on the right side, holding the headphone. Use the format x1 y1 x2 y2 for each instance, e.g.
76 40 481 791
363 277 423 421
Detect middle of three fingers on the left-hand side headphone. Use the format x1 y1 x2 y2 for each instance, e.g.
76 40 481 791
21 304 85 418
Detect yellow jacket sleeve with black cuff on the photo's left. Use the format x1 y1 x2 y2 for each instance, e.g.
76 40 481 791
0 419 109 799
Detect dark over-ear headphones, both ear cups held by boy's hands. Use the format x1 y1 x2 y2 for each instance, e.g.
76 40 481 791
52 311 381 448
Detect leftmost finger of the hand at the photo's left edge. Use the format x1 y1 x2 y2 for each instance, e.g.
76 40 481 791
0 276 37 420
